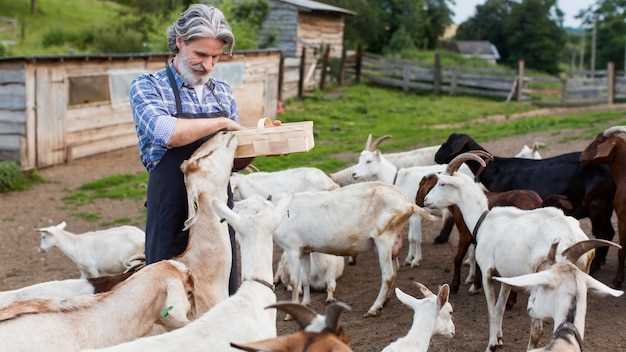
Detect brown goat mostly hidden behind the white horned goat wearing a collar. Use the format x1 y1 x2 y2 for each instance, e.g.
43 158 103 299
415 175 543 293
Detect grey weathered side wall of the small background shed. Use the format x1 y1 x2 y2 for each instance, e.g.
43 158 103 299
259 0 299 57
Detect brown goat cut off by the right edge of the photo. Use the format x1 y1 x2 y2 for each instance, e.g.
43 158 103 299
580 126 626 288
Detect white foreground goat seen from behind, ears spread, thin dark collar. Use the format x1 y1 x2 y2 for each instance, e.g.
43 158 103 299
89 196 290 352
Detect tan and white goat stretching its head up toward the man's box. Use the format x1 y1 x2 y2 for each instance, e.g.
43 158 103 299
177 132 238 316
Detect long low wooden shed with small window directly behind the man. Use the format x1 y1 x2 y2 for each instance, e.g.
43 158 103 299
0 50 281 169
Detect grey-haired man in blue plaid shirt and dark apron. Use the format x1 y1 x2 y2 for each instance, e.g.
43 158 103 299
130 4 250 294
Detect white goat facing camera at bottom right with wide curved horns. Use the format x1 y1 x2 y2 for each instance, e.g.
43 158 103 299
494 240 624 349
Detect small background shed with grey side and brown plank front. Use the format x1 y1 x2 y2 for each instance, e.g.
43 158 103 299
259 0 356 57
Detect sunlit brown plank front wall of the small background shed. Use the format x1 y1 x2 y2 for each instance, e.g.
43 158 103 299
298 12 344 58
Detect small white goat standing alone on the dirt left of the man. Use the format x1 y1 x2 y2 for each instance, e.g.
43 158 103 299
37 222 146 278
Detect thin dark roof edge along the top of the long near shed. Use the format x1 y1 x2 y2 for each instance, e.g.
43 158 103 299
0 49 281 64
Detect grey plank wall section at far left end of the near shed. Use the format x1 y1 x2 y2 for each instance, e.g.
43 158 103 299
0 64 26 161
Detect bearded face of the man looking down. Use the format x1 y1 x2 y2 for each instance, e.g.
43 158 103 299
176 38 224 85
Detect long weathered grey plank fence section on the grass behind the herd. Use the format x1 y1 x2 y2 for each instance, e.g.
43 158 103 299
363 53 528 100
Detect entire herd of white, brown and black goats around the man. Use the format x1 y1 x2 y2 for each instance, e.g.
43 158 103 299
0 126 626 352
